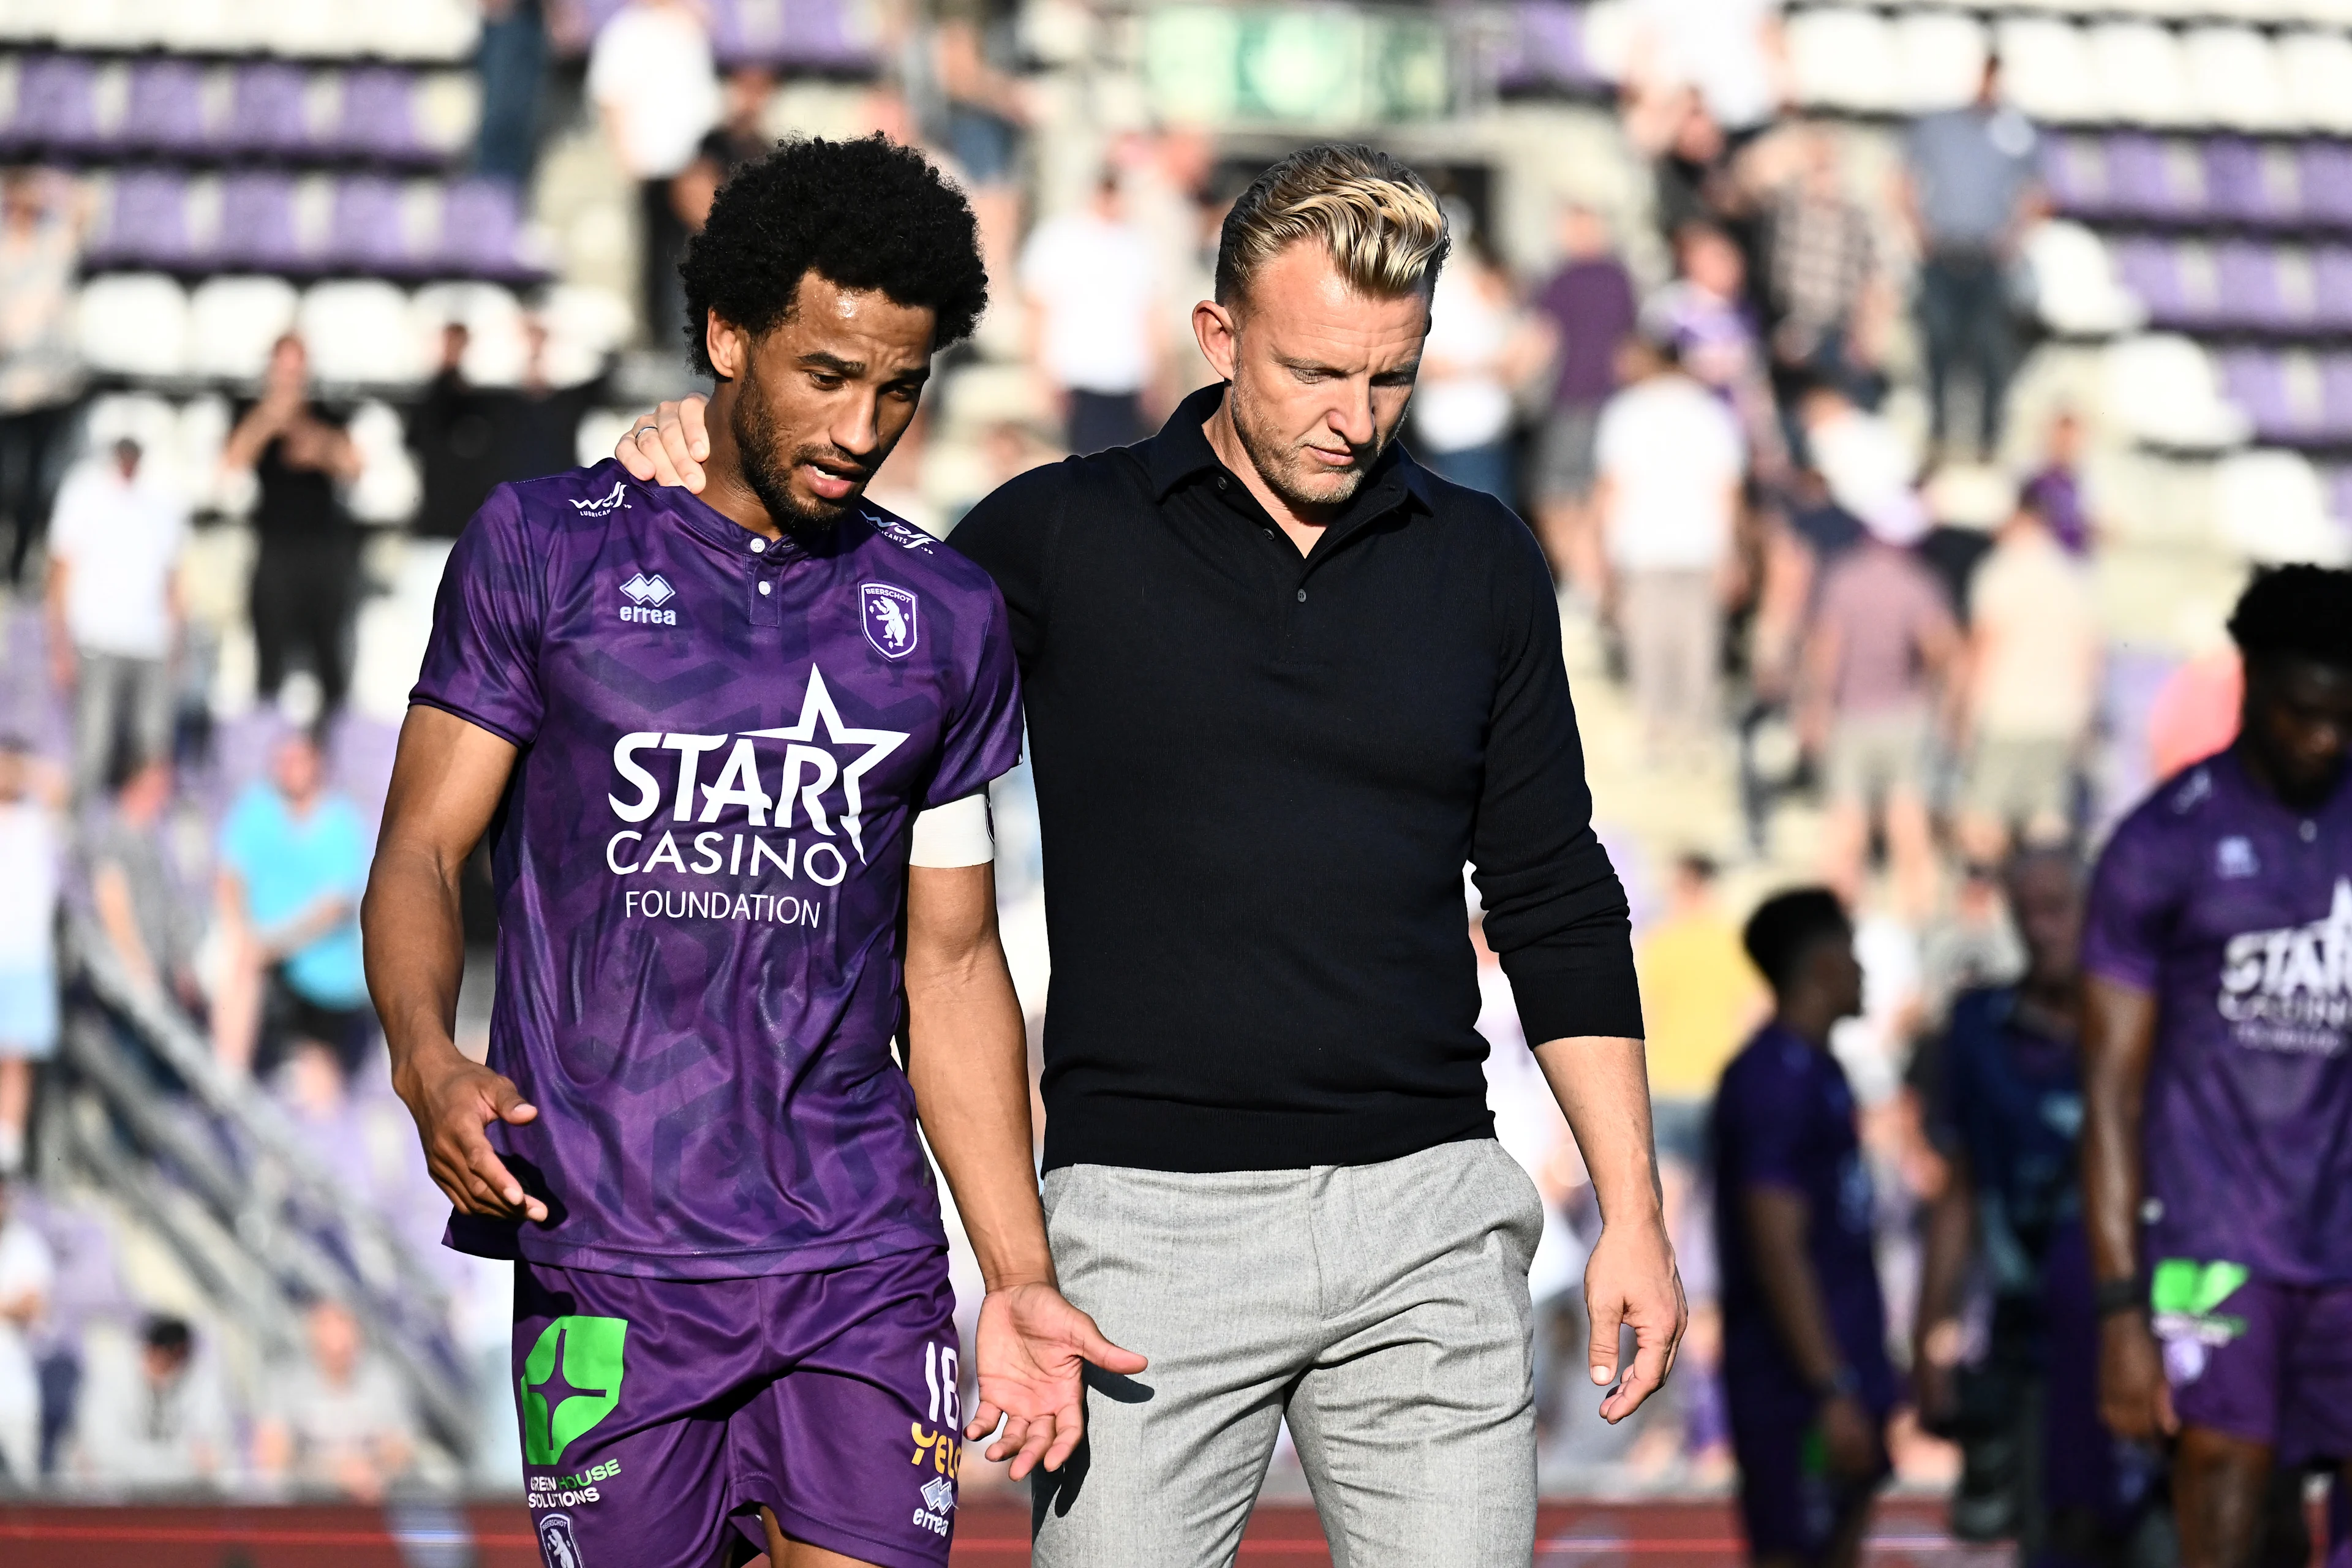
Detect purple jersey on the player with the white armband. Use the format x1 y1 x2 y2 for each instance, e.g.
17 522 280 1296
412 463 1021 1279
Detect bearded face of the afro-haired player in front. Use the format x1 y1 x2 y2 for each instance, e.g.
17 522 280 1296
703 273 938 531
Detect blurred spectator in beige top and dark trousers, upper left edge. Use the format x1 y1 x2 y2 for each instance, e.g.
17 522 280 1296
0 169 82 588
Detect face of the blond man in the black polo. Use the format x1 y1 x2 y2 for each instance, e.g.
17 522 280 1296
1193 239 1430 513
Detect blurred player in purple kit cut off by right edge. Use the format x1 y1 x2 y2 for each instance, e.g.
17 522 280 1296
2081 567 2352 1568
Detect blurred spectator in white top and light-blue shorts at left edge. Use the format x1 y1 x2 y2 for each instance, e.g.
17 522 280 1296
0 736 64 1178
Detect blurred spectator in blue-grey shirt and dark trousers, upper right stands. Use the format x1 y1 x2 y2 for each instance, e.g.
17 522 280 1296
1901 56 2039 454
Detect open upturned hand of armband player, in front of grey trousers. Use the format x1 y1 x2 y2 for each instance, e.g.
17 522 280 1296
964 1284 1148 1481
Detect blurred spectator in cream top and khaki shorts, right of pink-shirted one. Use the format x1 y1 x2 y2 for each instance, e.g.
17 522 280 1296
1959 503 2100 865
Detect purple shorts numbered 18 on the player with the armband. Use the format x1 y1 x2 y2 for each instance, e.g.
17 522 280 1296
513 1251 962 1568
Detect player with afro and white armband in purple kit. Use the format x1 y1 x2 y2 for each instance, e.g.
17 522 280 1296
364 137 1143 1568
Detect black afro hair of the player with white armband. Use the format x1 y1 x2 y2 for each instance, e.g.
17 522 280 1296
677 132 988 376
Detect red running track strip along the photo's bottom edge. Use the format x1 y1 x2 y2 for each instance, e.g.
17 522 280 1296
0 1500 2008 1568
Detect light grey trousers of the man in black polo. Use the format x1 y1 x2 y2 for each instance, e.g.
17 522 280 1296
1033 1138 1543 1568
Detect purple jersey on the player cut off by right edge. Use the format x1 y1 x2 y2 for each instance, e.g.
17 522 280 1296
2084 750 2352 1284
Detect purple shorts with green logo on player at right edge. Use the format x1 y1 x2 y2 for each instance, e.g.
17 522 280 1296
2150 1257 2352 1464
